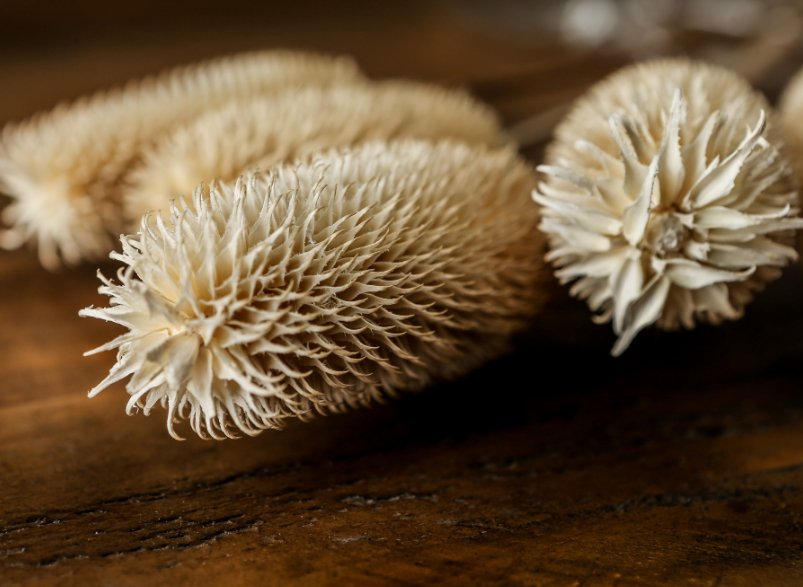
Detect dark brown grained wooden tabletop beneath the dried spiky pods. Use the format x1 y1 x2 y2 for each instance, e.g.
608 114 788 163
0 0 803 586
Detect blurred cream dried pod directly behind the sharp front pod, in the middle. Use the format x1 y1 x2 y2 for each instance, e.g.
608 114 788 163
124 81 505 227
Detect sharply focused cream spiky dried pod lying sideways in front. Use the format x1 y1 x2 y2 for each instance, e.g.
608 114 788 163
81 141 543 438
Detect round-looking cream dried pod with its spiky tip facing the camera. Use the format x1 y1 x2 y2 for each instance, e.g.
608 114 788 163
534 60 801 355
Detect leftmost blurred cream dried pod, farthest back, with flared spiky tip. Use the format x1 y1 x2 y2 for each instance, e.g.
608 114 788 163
0 51 361 268
